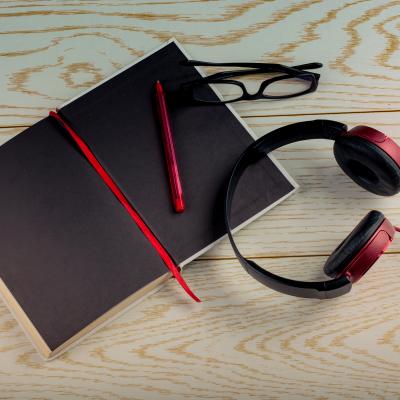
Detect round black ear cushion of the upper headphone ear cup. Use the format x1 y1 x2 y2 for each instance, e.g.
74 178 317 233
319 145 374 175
333 135 400 196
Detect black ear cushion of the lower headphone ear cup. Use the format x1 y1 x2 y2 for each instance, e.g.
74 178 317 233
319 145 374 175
324 210 385 278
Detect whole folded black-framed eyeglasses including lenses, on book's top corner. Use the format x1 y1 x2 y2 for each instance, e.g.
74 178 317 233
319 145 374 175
180 60 322 104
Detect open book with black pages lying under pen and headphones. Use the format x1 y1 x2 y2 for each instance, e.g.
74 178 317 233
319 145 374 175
0 40 296 359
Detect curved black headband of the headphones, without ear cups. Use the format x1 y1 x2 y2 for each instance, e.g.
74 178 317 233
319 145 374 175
225 120 351 299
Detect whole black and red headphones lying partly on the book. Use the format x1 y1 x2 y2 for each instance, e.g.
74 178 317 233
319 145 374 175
225 120 400 299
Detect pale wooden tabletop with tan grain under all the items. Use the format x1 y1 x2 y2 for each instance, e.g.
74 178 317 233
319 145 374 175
0 0 400 400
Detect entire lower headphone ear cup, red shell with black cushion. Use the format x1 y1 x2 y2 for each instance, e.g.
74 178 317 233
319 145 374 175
324 210 395 283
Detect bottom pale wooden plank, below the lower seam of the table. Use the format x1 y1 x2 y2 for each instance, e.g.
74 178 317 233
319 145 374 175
0 255 400 400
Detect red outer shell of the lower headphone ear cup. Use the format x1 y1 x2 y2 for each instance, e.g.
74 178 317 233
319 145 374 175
339 218 395 283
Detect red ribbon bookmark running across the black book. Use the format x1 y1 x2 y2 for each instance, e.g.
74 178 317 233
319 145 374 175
49 111 201 302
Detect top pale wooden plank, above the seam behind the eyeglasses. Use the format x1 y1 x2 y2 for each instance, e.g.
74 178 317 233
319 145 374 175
0 0 400 126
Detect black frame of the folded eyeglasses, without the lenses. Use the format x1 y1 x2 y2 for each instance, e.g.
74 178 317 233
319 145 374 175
180 60 322 104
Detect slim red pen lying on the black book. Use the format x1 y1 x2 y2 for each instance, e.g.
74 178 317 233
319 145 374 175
156 81 185 213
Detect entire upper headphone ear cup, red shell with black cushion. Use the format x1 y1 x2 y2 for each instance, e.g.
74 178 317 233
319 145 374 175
333 126 400 196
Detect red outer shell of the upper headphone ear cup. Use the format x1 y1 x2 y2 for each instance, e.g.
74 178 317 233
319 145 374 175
344 125 400 167
